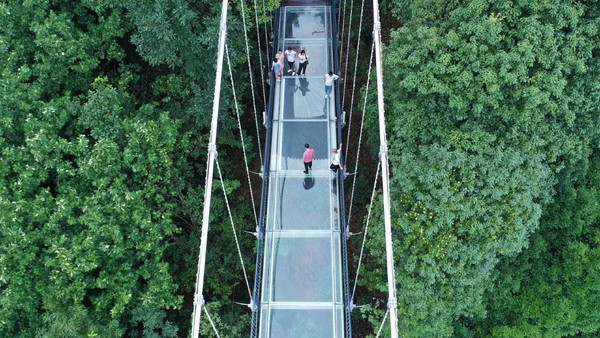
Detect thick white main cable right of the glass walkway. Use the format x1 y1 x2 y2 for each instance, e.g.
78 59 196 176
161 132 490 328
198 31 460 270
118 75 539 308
373 0 398 338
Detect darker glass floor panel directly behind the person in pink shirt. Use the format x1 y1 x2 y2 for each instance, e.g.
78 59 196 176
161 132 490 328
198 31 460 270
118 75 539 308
280 121 330 173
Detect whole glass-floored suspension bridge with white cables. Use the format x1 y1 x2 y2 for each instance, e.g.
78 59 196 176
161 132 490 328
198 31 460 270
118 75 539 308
192 0 398 338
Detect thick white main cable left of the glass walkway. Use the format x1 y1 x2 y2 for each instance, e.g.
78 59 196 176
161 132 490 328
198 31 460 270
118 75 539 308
192 0 228 338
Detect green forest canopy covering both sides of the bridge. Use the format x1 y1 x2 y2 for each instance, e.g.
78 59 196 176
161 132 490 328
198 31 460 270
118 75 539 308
0 0 600 337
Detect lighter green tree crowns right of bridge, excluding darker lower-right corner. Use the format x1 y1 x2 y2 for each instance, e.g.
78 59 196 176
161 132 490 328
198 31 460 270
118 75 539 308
358 0 600 337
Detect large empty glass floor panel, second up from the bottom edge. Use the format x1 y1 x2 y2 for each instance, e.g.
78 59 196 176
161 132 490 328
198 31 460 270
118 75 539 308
271 237 333 302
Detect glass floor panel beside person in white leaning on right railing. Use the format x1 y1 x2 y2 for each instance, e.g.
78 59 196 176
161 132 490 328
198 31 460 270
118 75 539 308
283 76 330 120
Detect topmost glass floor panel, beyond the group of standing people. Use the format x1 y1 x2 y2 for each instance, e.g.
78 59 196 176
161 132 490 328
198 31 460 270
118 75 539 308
284 6 331 39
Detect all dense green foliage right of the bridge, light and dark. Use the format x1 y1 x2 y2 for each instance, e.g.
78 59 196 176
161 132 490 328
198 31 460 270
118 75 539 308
358 0 600 337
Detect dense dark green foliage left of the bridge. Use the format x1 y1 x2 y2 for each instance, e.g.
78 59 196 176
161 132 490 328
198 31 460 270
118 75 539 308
0 0 264 337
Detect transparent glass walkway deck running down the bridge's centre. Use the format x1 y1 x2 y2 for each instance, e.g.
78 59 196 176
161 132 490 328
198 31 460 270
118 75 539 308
258 6 344 338
